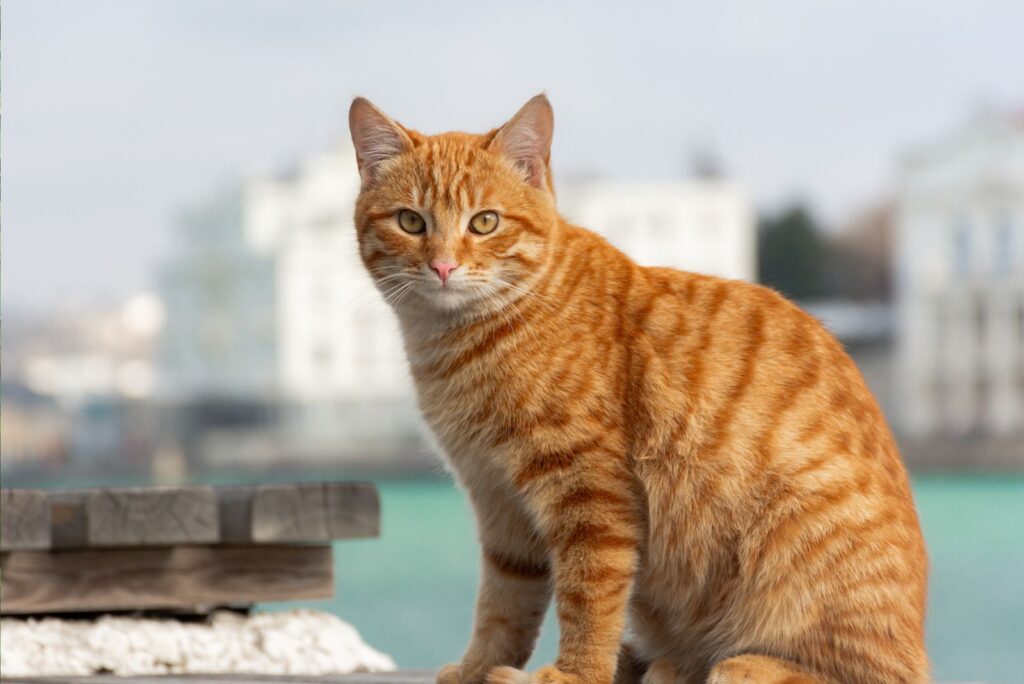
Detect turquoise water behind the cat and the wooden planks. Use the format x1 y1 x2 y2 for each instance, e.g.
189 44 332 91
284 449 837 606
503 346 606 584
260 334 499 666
4 472 1024 684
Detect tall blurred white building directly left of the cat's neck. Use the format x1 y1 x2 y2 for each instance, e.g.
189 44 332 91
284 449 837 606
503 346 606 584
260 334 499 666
244 146 410 400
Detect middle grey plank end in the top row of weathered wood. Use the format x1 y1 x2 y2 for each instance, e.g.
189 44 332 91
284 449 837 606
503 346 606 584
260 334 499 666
85 486 219 546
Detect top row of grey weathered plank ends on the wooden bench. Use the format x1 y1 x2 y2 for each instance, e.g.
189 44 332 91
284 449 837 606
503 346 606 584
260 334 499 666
2 482 380 551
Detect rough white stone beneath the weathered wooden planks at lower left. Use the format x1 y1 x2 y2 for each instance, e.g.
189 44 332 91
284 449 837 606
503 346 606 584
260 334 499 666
0 610 395 677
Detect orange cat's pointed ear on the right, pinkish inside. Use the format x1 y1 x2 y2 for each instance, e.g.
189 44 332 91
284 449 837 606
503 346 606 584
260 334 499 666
487 93 555 189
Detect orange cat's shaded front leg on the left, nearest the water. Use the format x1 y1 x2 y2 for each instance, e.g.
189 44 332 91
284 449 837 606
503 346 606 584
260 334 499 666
437 481 551 684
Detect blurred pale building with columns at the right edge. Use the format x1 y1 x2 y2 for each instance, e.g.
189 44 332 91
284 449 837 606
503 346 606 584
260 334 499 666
895 109 1024 436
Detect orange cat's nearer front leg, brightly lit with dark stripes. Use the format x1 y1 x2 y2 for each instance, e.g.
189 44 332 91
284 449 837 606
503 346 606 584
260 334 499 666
487 440 641 684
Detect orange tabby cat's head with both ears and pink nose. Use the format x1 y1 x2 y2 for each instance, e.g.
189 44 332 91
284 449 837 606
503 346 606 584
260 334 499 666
349 95 557 315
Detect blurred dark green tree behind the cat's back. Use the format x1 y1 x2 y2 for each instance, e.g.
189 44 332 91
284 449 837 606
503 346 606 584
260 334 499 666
758 205 830 299
